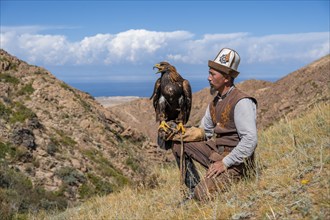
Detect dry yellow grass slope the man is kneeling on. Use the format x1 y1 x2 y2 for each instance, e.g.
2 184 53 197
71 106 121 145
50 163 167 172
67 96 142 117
30 104 330 220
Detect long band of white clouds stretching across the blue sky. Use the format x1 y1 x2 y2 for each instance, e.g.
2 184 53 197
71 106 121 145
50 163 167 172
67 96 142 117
0 26 330 65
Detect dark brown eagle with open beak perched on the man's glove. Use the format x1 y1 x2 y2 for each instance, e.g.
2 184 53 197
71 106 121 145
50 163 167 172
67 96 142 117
150 62 192 134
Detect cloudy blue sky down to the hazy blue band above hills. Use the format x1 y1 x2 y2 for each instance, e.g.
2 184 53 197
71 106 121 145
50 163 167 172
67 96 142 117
0 0 330 96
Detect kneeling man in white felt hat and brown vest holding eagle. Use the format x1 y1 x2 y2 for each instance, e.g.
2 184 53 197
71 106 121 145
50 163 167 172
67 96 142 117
172 48 257 201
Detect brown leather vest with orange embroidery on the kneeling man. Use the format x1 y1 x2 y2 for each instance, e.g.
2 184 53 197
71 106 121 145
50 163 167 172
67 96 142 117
210 88 257 147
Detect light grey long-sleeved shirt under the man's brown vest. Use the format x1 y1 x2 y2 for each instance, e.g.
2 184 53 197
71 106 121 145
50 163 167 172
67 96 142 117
200 98 258 167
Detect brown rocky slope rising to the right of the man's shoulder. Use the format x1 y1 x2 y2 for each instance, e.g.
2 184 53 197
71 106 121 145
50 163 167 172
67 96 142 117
255 55 330 128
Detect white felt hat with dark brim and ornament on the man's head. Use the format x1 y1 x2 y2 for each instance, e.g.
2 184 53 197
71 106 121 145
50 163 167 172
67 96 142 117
209 48 240 78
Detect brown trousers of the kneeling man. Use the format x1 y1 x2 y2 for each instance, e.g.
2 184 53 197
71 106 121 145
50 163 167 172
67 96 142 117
172 141 245 201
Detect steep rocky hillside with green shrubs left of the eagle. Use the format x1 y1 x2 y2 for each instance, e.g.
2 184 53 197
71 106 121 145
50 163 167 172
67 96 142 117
0 50 166 214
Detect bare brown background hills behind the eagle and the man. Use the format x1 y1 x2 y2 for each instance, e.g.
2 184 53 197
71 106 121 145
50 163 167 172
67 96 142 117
108 55 330 141
